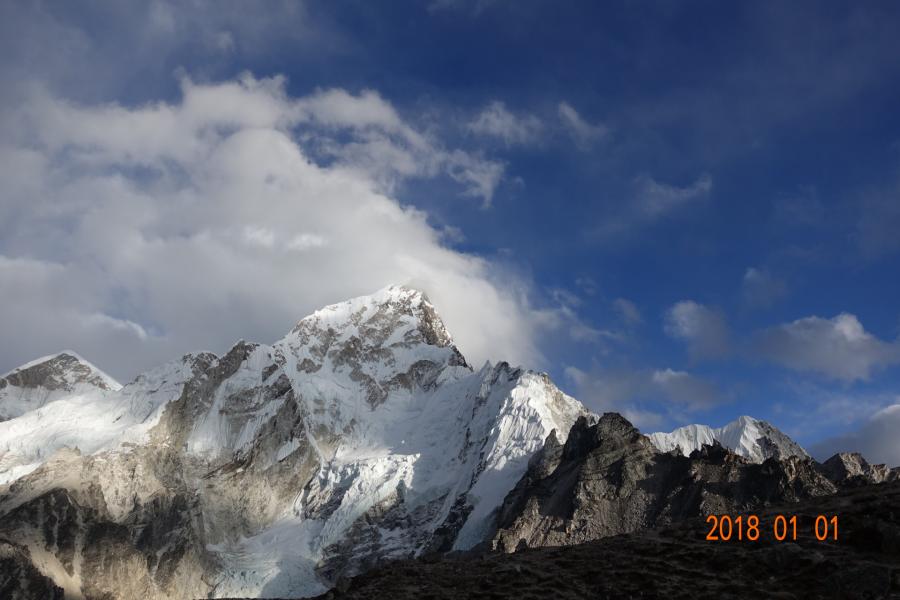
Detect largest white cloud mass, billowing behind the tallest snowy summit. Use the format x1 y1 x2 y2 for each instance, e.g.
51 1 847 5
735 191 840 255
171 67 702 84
0 76 548 378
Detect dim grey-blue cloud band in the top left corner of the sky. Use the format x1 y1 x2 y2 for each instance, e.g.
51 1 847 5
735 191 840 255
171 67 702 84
0 0 324 108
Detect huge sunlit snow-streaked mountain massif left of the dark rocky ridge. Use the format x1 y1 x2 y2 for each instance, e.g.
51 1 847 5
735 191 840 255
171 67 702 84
0 287 587 599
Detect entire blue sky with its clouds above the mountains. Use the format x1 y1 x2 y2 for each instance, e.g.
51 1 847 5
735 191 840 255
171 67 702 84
0 0 900 463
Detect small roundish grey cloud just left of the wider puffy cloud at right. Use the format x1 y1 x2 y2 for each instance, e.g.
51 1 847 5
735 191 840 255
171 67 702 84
665 300 729 359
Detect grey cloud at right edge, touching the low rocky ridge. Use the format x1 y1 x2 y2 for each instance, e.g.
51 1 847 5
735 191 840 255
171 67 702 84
812 403 900 467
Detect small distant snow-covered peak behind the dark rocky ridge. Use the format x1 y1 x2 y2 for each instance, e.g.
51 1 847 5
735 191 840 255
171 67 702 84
649 415 809 462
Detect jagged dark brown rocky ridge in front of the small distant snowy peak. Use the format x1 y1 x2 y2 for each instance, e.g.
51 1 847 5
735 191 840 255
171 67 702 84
494 413 837 552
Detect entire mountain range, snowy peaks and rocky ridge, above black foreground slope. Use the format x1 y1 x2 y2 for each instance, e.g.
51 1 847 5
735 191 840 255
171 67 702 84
0 287 897 600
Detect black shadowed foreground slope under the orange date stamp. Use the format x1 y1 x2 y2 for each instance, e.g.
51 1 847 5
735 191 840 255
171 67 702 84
308 482 900 600
